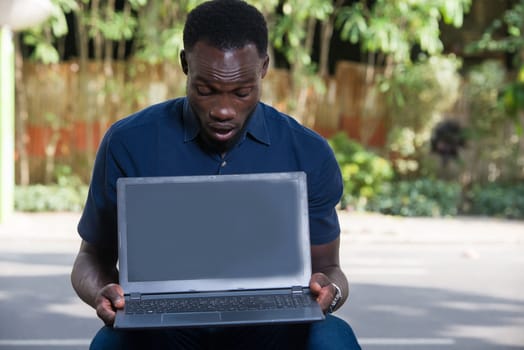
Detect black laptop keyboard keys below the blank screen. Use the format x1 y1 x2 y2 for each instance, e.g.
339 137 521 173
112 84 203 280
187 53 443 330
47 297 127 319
125 294 315 314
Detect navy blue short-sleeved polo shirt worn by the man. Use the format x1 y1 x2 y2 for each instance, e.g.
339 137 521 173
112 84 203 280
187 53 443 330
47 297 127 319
78 98 342 248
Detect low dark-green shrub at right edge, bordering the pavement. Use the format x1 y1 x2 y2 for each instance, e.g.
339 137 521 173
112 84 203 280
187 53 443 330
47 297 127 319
467 183 524 219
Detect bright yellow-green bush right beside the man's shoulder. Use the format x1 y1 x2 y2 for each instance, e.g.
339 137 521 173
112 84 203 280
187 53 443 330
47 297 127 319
329 133 393 209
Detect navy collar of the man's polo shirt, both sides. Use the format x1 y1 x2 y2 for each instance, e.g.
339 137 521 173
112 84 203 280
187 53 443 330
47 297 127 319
182 98 271 145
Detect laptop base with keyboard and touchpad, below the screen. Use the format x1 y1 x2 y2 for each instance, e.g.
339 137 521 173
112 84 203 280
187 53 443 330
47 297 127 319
114 288 325 329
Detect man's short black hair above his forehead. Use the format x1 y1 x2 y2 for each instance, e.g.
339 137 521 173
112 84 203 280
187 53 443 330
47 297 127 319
184 0 268 57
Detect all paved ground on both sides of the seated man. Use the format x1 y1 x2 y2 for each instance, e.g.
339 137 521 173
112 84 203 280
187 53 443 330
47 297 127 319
0 213 524 350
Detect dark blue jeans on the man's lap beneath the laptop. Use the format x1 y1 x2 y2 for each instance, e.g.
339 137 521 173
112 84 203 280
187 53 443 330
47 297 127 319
90 315 360 350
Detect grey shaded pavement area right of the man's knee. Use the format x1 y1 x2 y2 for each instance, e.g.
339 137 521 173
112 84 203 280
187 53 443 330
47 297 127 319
339 283 524 350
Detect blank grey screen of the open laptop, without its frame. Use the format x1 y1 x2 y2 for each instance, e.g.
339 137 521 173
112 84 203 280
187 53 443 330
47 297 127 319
126 180 303 282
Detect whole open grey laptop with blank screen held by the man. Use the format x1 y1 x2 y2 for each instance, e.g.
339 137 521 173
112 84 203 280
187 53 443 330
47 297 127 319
114 172 324 329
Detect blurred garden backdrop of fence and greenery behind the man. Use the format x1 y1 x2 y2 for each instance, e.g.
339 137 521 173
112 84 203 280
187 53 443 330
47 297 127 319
2 0 524 218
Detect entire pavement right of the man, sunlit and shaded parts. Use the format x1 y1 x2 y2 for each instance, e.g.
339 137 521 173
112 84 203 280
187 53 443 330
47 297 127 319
339 214 524 350
